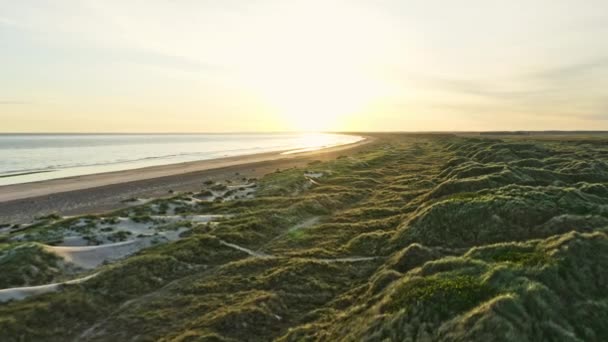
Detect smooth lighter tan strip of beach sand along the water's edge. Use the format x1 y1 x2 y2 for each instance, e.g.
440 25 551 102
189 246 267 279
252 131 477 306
0 137 372 203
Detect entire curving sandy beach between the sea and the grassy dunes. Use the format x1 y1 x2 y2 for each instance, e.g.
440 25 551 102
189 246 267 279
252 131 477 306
0 136 374 224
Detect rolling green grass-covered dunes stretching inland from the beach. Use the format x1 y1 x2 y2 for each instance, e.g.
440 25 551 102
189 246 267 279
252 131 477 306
0 134 608 341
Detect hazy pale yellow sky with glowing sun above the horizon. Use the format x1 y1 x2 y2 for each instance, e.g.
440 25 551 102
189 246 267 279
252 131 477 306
0 0 608 132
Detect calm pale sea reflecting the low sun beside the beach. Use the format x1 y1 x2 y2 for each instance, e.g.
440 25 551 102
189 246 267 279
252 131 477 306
0 133 362 185
